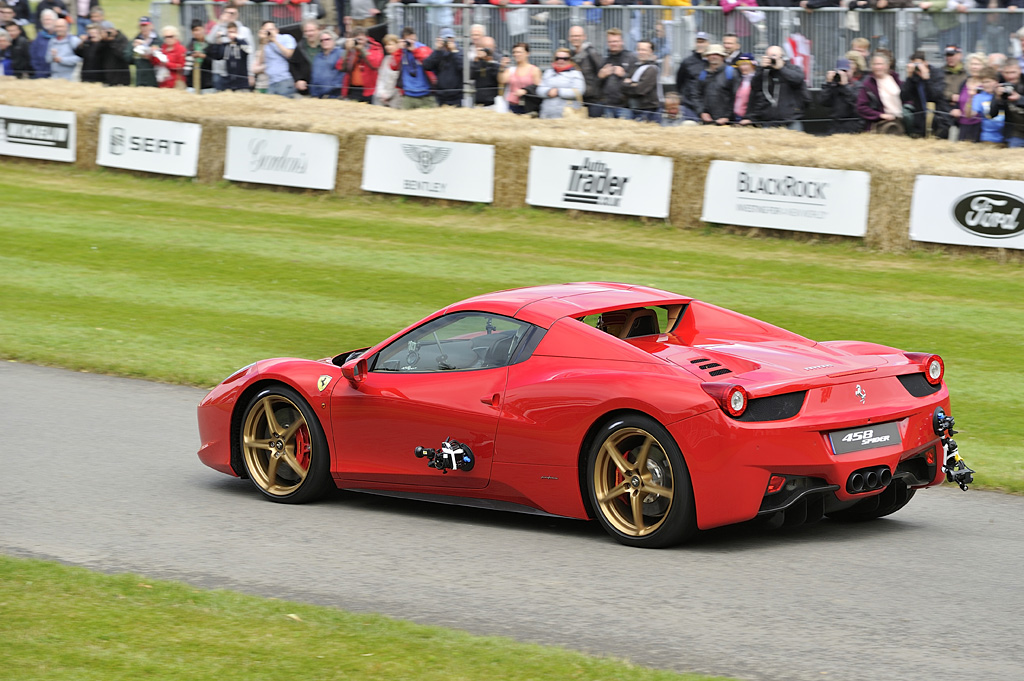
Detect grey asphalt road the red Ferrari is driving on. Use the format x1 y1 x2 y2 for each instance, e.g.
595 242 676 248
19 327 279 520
0 363 1024 681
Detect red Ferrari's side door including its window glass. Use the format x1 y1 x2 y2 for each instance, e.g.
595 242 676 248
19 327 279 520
331 312 531 488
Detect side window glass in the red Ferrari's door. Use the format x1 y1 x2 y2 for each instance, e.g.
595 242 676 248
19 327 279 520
371 312 532 373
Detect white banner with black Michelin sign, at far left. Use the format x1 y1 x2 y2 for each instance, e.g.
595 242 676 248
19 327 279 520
0 104 76 163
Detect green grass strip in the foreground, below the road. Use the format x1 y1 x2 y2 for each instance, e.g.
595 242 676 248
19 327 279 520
0 556 729 681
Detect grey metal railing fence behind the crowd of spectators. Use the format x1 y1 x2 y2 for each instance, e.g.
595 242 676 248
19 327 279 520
151 0 1024 87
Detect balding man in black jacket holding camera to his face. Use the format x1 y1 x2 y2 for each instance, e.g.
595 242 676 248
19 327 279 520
749 45 810 132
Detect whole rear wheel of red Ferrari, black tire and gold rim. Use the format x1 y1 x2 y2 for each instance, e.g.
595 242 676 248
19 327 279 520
587 414 696 549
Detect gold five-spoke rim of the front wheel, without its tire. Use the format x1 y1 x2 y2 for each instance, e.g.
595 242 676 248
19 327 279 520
242 394 312 497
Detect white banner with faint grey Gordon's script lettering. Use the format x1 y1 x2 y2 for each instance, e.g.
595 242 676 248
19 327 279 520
224 126 338 189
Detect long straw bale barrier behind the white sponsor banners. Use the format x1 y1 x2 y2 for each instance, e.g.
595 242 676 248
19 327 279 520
0 78 1024 258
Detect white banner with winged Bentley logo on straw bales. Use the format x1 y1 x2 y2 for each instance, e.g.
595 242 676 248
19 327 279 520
362 135 495 204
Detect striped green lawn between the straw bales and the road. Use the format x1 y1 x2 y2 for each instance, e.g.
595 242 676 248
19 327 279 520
0 160 1024 493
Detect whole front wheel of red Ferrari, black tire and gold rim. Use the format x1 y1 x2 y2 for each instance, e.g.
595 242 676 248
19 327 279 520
239 385 334 504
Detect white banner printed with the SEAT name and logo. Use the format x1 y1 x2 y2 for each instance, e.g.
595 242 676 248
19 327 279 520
96 114 203 177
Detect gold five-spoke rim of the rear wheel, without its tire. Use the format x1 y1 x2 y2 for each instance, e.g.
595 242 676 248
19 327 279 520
594 428 674 537
